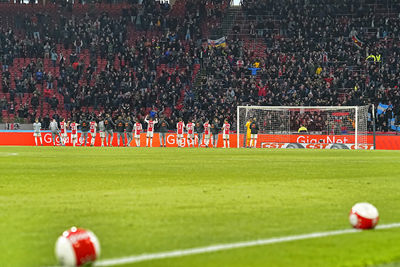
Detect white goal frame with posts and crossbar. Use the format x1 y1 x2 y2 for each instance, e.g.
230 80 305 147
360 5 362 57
236 105 375 149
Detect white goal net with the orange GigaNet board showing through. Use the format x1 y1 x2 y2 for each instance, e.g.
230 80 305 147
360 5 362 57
236 106 373 149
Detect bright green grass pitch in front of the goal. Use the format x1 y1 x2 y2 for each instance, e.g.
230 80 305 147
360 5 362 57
0 147 400 267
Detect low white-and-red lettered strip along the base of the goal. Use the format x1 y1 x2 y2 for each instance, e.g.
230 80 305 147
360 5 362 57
260 142 374 150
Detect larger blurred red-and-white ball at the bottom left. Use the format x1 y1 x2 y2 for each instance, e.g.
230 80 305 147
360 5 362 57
56 227 100 267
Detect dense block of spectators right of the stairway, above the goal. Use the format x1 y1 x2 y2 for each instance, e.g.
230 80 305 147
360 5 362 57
199 0 400 131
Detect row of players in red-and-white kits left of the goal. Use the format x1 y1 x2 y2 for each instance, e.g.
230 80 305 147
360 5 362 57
33 114 231 148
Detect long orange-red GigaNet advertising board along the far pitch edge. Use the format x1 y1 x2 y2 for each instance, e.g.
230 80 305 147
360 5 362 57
0 130 400 150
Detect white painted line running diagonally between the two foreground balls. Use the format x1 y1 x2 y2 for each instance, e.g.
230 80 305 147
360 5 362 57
94 223 400 266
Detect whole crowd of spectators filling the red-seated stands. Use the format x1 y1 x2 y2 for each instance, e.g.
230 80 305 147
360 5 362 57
0 0 400 131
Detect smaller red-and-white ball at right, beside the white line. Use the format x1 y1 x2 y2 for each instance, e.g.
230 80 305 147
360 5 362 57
349 203 379 229
